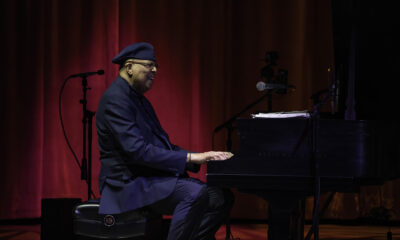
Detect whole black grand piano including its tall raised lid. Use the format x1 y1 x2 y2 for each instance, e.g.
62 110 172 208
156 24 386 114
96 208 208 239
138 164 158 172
207 0 400 240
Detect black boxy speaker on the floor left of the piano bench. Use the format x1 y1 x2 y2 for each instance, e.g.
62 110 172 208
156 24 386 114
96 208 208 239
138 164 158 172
40 198 81 240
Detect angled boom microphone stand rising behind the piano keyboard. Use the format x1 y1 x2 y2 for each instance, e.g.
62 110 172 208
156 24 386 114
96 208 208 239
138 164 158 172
214 90 272 240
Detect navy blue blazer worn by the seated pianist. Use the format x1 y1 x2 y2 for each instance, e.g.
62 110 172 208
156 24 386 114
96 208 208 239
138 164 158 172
96 76 199 214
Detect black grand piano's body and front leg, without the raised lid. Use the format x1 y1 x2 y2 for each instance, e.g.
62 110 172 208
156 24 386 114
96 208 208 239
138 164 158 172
207 118 394 240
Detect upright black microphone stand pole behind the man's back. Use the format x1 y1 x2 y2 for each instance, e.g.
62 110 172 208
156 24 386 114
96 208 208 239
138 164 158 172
79 76 95 200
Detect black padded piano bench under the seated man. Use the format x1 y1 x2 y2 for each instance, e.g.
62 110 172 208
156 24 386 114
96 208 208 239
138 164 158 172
73 199 168 240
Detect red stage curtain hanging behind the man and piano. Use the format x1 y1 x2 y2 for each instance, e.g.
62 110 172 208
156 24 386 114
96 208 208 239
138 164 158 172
0 0 399 219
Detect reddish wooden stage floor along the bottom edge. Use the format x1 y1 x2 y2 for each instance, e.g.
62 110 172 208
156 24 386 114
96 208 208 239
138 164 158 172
0 224 400 240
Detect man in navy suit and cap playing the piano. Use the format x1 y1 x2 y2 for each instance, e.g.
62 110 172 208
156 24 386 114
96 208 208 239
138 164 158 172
96 43 233 240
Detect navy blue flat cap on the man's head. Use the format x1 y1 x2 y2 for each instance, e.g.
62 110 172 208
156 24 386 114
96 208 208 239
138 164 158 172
112 42 156 65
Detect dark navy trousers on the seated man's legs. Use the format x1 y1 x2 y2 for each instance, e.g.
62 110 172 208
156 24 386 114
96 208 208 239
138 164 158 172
149 178 234 240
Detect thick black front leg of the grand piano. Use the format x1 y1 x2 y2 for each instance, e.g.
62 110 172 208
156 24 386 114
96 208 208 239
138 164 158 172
262 192 303 240
